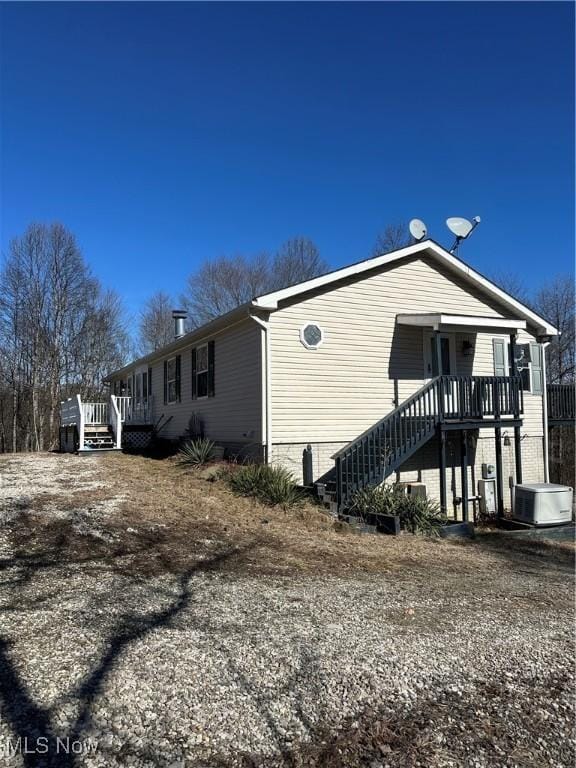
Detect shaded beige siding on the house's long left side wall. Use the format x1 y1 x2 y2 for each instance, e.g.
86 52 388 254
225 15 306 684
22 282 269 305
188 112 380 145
127 319 262 444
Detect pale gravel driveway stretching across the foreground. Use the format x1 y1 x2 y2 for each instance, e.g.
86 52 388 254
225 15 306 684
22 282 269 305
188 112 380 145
0 456 574 768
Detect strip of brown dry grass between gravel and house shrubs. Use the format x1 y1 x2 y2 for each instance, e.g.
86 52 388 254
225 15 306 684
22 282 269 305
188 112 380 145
92 454 573 576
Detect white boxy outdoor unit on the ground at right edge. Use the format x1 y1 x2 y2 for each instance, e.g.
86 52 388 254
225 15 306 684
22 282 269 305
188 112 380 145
514 483 573 525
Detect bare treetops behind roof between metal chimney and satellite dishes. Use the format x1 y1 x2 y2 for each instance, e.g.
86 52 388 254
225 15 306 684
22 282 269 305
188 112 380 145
180 237 327 327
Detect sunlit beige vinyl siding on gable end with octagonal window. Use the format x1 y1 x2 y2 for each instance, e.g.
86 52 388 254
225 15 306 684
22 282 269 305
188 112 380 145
270 257 542 445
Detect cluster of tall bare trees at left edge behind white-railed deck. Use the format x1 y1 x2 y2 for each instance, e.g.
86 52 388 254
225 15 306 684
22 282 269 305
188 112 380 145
0 224 127 451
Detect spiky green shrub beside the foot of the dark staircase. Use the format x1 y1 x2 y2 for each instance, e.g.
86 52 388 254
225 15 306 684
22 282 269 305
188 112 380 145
349 484 445 536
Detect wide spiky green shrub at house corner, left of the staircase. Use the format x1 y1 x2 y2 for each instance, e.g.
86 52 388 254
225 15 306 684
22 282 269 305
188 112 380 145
227 464 302 507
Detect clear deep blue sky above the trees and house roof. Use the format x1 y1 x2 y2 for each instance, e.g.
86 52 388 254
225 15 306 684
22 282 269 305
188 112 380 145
1 2 574 310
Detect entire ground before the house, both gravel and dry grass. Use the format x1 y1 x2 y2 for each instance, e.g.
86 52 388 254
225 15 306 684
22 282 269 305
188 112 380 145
0 453 574 768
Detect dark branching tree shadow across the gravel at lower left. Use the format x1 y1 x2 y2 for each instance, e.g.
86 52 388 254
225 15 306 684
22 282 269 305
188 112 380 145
0 520 253 768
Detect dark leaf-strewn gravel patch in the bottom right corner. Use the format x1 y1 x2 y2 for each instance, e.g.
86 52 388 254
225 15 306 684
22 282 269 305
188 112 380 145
226 674 575 768
